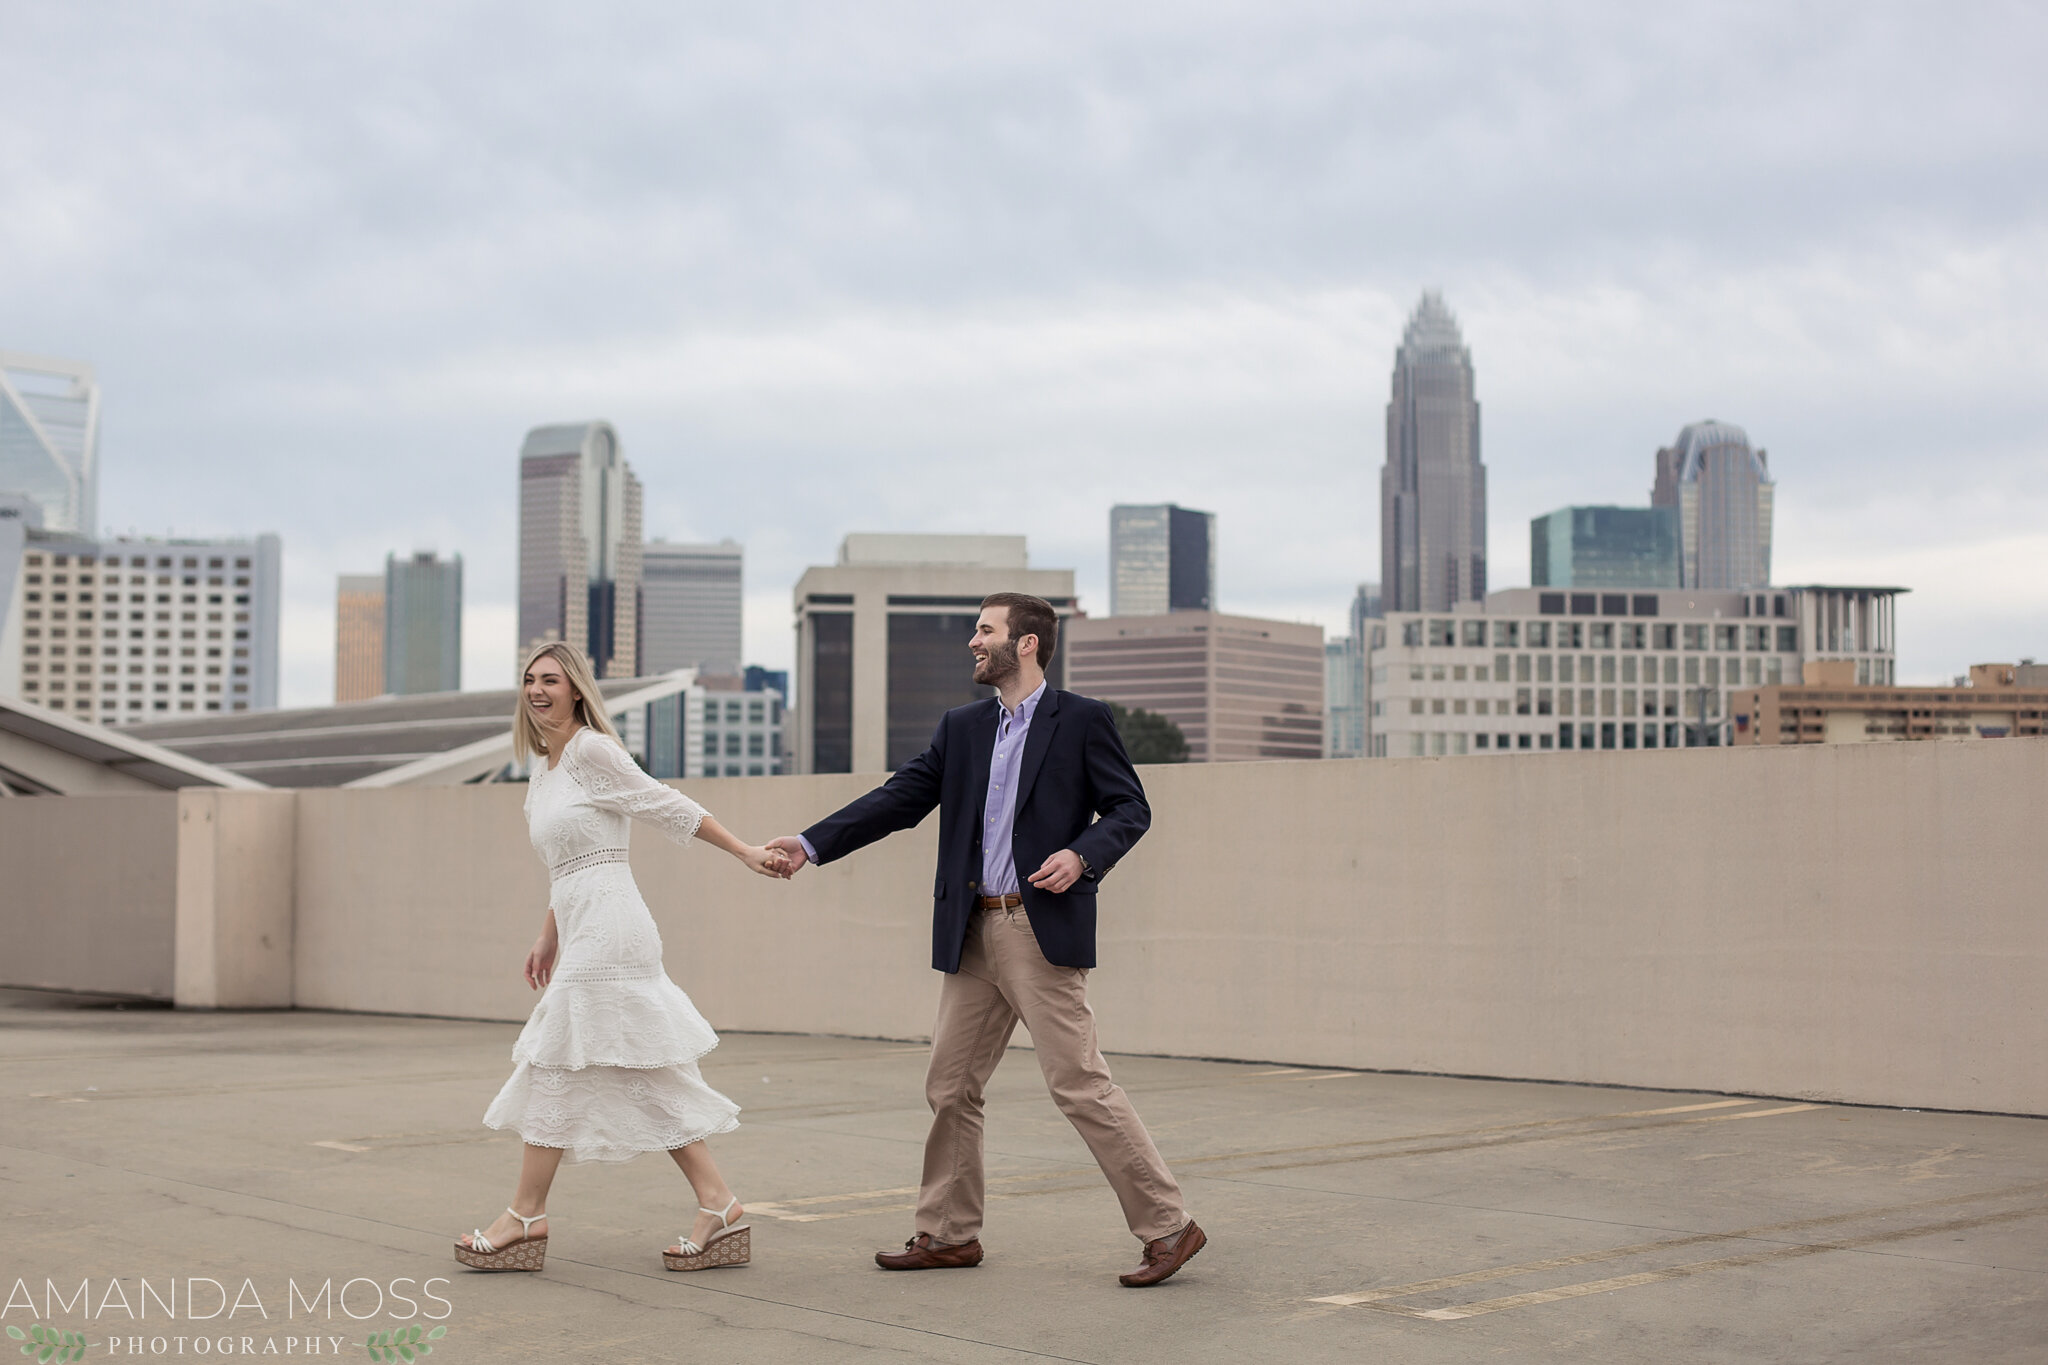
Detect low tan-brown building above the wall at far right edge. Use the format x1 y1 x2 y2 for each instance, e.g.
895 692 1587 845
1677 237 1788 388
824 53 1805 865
1729 659 2048 745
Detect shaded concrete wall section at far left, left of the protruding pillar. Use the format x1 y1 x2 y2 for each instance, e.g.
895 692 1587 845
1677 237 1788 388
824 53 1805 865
0 792 178 1001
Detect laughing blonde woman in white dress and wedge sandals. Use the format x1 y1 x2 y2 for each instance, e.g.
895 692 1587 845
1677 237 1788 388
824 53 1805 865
455 643 788 1271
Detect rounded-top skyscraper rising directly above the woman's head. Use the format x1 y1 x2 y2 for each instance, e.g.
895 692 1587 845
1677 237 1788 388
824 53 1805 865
518 422 641 677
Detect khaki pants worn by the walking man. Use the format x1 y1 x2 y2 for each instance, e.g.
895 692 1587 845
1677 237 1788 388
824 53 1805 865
918 907 1188 1242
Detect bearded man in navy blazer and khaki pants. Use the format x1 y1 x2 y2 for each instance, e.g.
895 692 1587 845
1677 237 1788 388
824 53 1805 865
770 593 1208 1287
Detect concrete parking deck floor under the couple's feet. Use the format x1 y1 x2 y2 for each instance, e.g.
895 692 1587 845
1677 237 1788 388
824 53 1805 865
0 993 2048 1365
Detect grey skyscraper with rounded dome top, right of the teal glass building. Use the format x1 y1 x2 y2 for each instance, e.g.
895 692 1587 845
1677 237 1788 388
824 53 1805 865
1651 420 1774 587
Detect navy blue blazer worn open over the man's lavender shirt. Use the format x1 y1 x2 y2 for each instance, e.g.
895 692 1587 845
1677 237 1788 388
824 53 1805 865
803 688 1151 972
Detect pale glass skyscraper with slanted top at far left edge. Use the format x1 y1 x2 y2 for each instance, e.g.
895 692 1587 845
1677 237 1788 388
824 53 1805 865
0 350 100 536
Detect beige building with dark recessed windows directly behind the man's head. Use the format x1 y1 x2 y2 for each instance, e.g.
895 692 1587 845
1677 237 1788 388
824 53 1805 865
795 534 1081 774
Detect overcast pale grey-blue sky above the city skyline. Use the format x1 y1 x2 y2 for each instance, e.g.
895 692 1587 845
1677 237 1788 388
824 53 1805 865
0 0 2048 704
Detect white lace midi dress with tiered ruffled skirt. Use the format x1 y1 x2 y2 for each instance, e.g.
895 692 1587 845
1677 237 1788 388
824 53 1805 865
483 729 739 1160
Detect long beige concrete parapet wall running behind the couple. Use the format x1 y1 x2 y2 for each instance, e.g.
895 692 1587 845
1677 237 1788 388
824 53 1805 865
0 739 2048 1113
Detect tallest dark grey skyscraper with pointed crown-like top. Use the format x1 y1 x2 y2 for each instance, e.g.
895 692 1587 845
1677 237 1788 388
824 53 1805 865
1380 291 1487 612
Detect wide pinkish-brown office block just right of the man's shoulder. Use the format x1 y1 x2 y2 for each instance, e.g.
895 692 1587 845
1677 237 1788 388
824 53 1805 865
1061 612 1325 763
